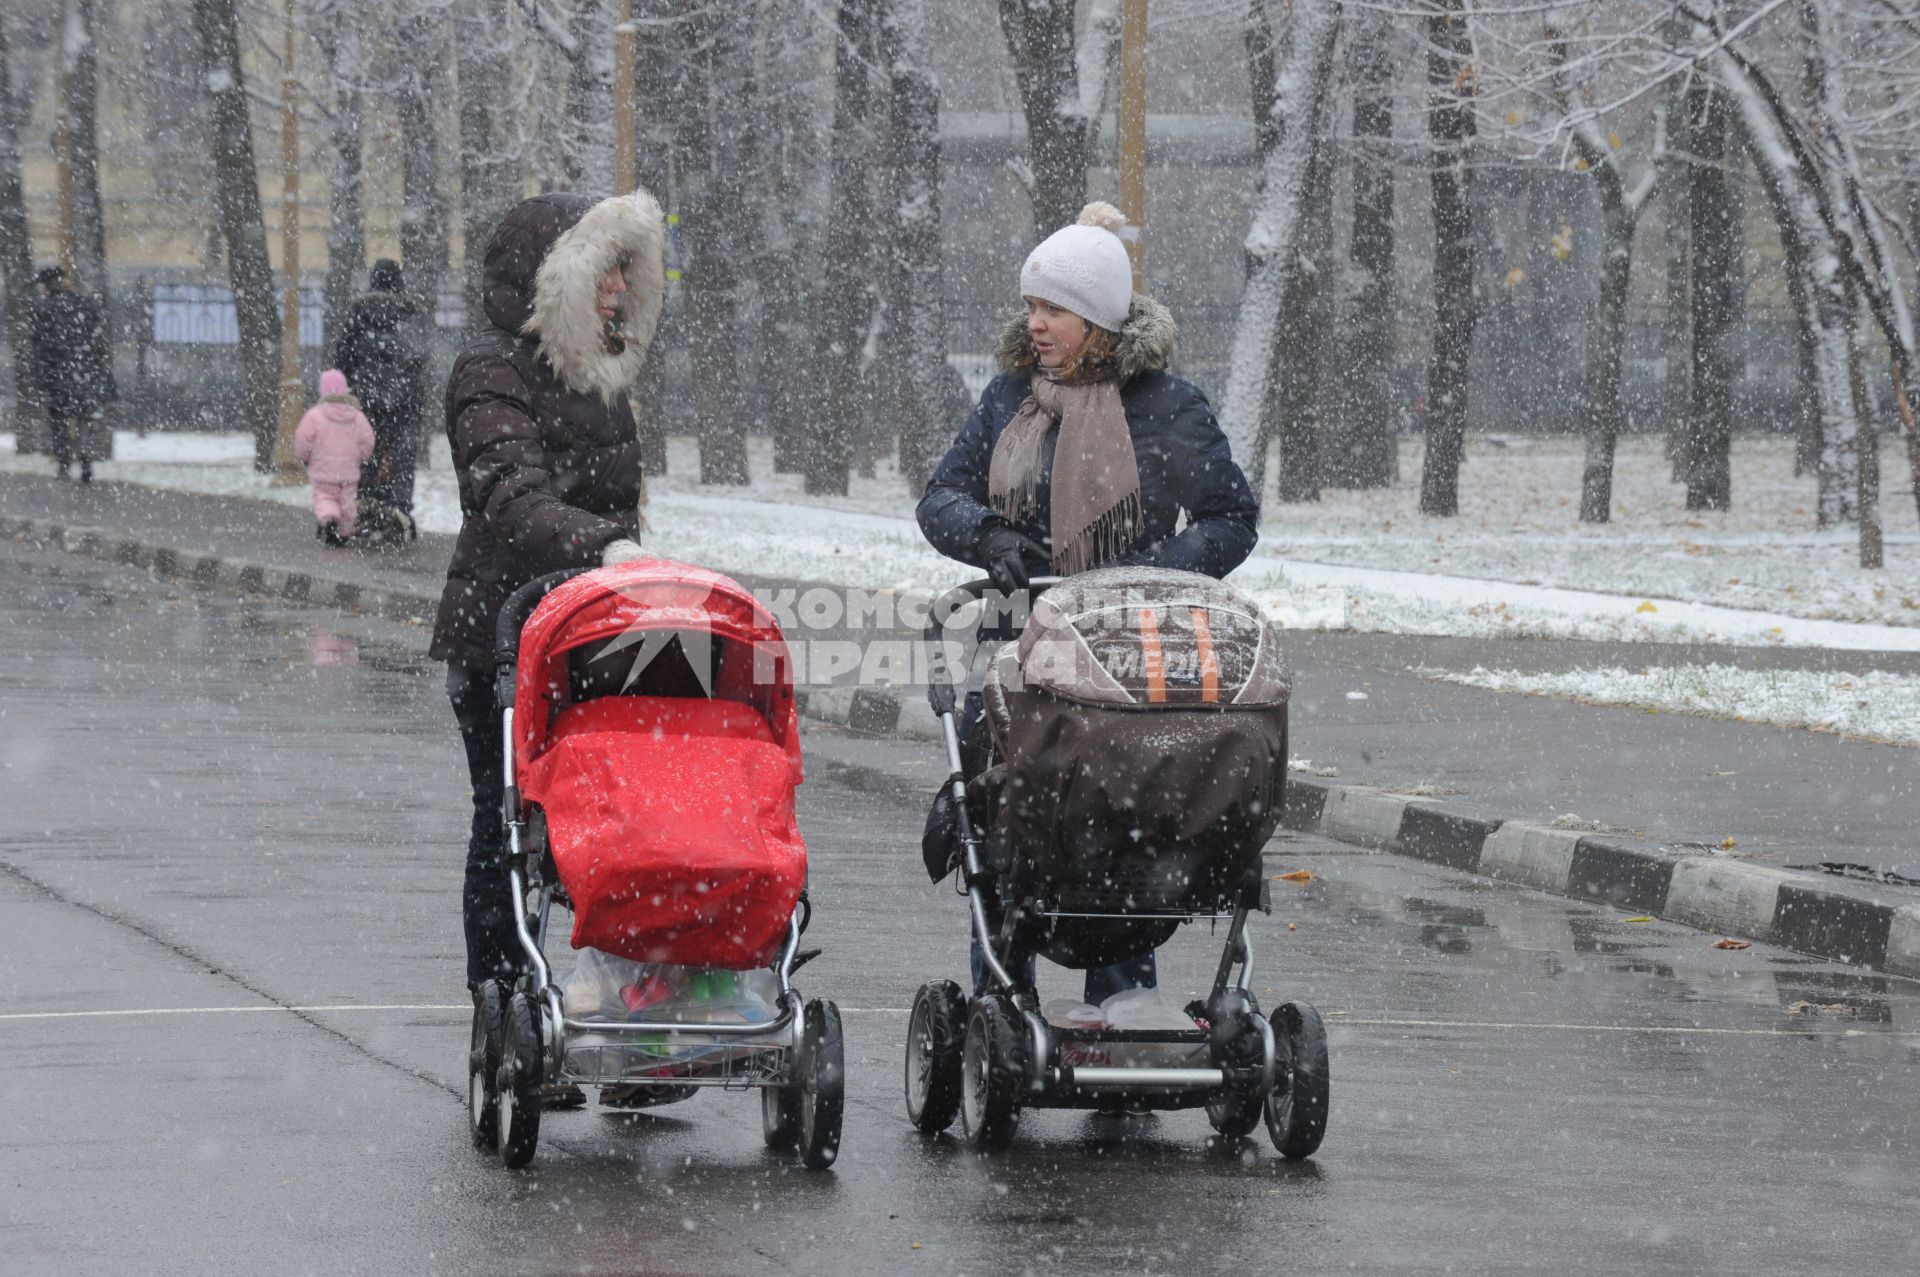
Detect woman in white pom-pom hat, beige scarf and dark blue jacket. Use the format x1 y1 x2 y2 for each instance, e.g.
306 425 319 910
918 202 1260 1004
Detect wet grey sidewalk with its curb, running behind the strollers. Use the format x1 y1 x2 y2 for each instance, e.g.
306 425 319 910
0 474 1920 976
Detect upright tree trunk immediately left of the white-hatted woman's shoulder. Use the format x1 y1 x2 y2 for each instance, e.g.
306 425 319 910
879 0 954 495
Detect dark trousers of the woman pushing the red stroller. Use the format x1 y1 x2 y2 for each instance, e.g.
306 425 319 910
447 664 524 989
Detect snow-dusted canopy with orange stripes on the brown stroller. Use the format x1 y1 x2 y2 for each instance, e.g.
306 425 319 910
996 566 1292 709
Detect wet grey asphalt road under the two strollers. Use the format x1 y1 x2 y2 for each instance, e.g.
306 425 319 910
0 547 1920 1275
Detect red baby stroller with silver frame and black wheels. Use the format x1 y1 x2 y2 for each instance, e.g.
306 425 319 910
468 561 845 1169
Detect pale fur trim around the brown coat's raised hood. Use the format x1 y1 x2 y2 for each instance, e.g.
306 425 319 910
524 190 666 403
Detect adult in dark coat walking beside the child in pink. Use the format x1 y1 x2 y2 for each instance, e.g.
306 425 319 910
334 257 430 515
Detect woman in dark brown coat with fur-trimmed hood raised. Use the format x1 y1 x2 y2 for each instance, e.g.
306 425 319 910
432 190 666 987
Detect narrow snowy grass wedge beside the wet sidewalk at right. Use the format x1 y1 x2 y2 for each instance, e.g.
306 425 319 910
1419 664 1920 745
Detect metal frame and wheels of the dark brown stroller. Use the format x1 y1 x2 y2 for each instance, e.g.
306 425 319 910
906 576 1327 1158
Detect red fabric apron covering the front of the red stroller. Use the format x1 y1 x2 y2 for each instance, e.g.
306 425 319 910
522 697 806 970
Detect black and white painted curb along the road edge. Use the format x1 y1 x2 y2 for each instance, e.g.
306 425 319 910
11 517 1920 977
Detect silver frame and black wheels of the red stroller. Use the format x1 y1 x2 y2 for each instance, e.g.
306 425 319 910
468 568 845 1169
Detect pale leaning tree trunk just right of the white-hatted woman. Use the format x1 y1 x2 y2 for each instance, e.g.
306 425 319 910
1221 0 1340 499
